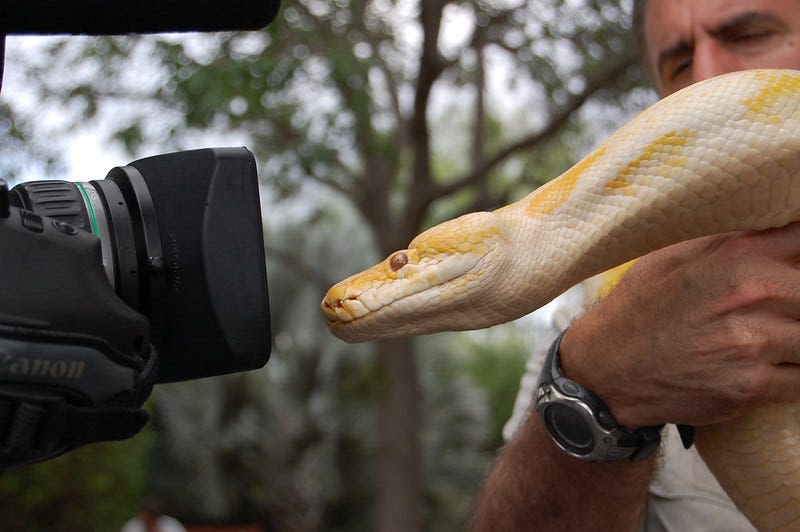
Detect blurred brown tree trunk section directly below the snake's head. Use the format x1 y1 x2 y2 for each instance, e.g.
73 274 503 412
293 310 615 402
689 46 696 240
377 338 421 532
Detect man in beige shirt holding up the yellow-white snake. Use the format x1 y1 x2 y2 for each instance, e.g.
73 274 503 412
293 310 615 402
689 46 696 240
473 0 800 531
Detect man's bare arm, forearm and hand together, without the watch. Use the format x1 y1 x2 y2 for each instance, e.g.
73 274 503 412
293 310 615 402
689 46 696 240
474 224 800 530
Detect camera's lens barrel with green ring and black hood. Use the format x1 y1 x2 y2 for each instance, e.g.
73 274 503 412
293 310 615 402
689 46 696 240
10 148 271 382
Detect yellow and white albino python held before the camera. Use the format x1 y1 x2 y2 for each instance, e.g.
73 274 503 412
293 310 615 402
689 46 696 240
322 70 800 530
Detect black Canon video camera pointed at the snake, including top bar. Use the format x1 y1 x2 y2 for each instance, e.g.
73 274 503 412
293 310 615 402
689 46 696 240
0 0 279 470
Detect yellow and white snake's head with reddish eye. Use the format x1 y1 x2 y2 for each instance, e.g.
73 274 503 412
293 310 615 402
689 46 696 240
321 212 520 342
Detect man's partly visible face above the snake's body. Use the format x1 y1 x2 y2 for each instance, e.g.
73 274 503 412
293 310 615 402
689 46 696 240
644 0 800 96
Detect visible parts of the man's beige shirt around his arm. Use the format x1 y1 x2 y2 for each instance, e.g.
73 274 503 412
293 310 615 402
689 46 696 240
503 289 755 532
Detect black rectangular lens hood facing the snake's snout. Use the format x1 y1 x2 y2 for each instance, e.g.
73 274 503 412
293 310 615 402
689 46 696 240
125 148 271 382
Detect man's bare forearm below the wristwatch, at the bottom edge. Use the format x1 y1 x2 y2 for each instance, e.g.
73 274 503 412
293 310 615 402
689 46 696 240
472 412 655 532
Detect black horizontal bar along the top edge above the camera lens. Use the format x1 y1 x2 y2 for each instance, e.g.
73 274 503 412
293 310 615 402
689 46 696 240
0 0 280 35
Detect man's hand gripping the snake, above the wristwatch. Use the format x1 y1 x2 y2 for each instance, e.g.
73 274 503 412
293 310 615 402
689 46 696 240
561 223 800 428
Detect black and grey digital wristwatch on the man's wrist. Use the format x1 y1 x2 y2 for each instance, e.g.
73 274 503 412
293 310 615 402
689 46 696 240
536 331 664 463
